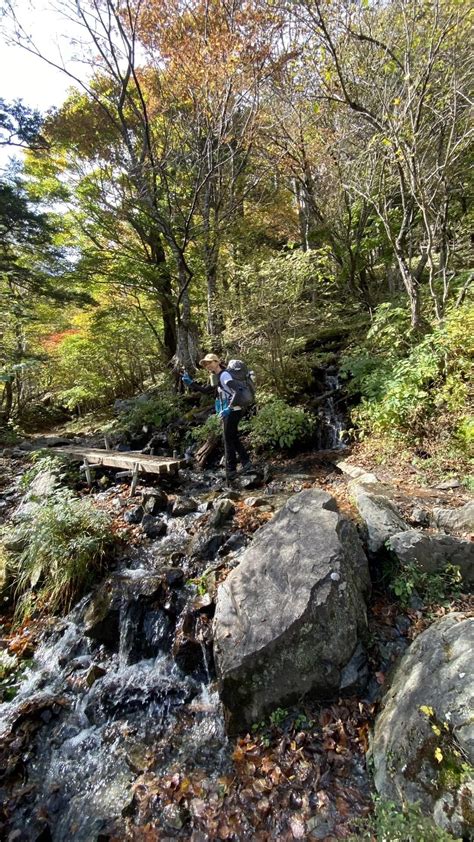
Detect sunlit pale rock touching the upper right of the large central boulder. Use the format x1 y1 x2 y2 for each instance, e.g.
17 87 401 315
349 480 408 554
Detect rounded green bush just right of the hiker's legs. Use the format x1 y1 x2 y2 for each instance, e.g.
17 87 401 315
250 399 316 450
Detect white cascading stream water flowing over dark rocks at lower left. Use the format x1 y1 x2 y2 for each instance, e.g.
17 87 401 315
0 476 237 842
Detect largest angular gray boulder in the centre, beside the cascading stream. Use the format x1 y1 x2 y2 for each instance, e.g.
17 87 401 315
214 489 370 733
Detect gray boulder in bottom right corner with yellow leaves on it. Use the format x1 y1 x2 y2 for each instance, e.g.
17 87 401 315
371 613 474 837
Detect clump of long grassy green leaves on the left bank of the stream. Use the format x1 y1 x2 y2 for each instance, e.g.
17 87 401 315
2 489 114 616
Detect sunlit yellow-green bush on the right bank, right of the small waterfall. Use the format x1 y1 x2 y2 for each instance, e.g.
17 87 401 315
342 304 474 450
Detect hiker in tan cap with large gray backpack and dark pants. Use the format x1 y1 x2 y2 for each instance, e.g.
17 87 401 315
181 354 254 479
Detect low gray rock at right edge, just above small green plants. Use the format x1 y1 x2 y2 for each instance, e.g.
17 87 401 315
387 529 474 585
